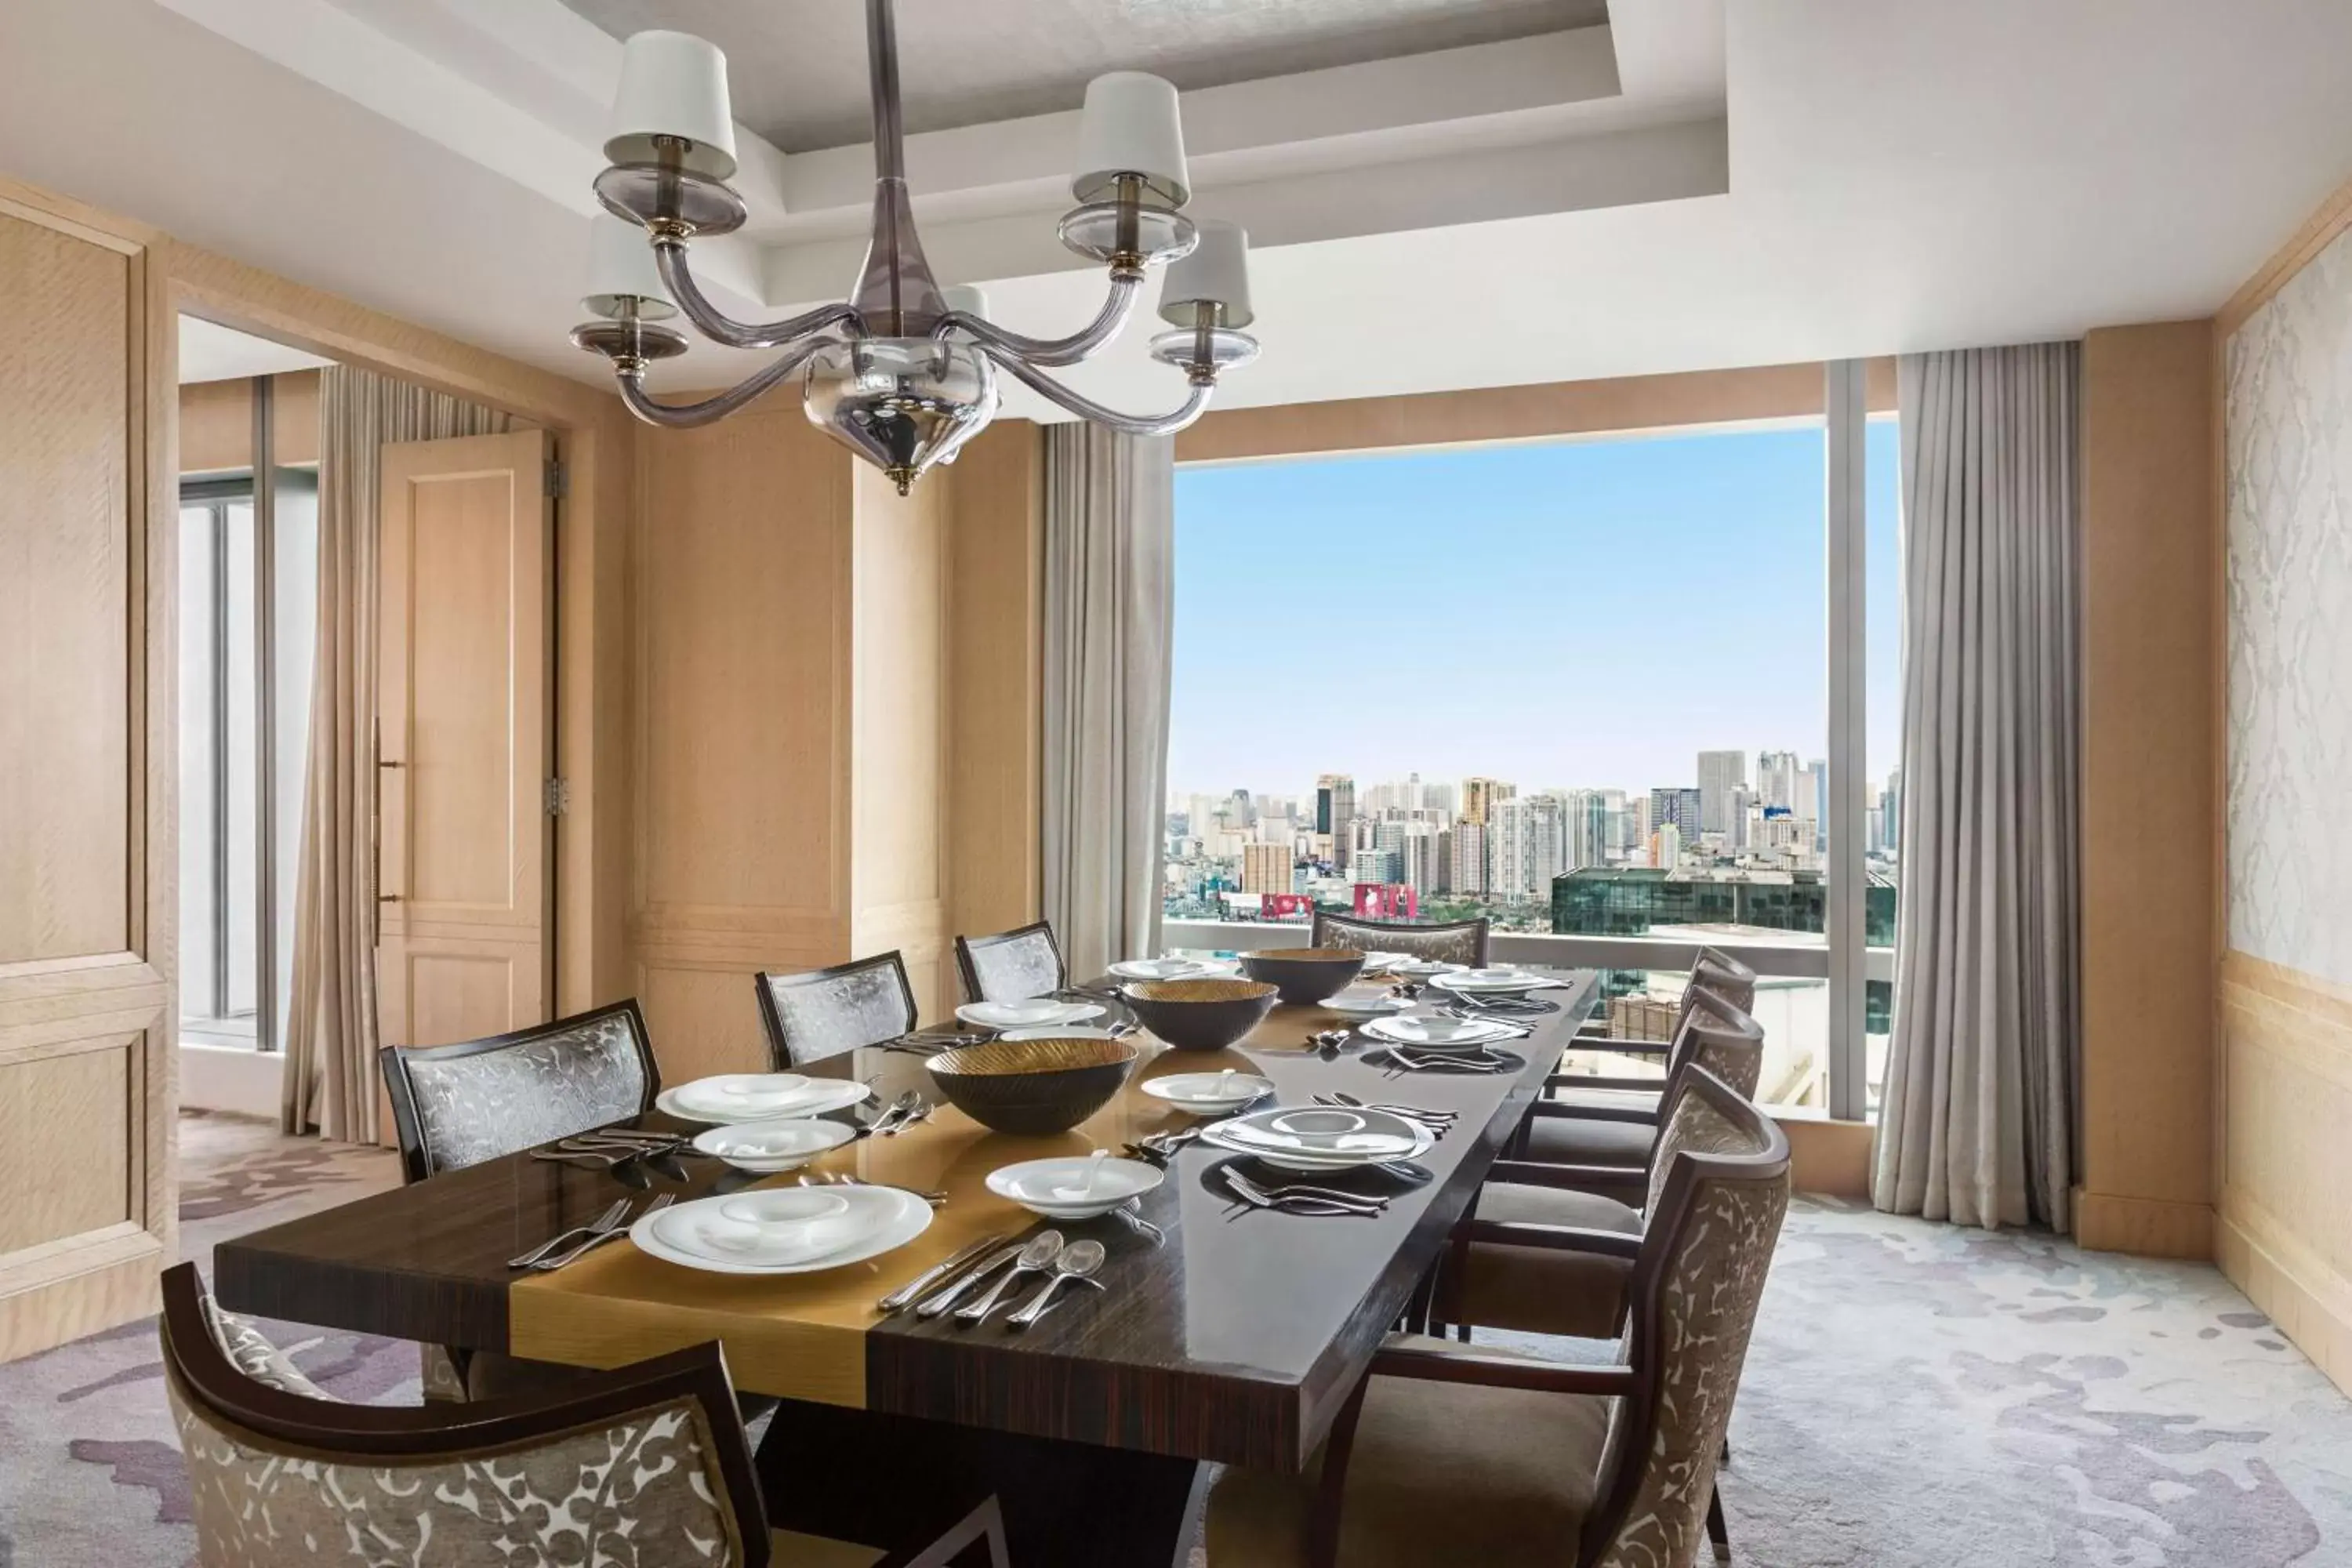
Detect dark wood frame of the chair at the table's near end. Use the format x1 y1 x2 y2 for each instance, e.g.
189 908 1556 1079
162 1262 1004 1568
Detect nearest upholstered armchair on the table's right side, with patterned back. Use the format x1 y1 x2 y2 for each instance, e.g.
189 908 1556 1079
1207 1067 1788 1568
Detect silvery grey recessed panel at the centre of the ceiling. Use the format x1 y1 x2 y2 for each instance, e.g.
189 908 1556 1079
564 0 1609 153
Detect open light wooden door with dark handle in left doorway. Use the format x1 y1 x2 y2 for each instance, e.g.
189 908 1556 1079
376 430 555 1062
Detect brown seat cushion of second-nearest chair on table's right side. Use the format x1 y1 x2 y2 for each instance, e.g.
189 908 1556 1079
1446 1182 1642 1340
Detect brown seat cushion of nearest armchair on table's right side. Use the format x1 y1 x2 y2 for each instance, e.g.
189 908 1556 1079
1209 1338 1611 1568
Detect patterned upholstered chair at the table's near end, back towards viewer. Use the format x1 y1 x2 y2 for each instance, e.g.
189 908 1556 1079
162 1262 1007 1568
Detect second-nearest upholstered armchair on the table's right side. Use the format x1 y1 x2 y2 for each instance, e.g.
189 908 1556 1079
1432 1062 1769 1340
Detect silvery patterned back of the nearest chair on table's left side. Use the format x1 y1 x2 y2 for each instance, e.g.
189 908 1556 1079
376 1001 661 1182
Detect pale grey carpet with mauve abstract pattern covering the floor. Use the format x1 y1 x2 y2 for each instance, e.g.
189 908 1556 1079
0 1114 2352 1568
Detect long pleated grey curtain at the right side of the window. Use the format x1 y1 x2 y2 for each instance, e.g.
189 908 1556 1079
1872 343 2082 1229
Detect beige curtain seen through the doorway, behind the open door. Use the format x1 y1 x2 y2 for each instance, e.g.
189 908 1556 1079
280 365 513 1142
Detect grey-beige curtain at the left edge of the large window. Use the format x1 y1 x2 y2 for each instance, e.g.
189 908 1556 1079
1044 423 1176 975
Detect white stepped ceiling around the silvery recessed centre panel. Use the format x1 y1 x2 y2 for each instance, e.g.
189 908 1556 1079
0 0 2352 423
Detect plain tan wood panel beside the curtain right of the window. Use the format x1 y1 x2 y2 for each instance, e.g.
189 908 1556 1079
2074 322 2220 1258
